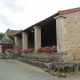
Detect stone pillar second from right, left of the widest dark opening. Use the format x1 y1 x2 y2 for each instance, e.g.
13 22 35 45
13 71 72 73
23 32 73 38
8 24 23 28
34 26 41 51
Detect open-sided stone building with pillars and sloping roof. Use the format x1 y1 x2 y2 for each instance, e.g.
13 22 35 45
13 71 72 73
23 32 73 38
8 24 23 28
15 8 80 60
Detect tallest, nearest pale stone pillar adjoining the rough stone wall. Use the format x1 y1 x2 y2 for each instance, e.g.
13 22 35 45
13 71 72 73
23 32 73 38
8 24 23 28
55 15 66 52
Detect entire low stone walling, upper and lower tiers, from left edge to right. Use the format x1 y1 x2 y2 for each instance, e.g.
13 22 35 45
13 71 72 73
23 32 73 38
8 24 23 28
0 53 79 71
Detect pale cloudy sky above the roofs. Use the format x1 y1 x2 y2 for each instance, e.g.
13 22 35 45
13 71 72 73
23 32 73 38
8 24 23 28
0 0 80 33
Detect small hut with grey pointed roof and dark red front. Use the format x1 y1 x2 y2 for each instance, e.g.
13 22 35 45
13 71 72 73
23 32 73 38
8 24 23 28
0 35 13 53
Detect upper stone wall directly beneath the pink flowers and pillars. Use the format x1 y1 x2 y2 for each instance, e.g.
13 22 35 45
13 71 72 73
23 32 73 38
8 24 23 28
21 53 66 63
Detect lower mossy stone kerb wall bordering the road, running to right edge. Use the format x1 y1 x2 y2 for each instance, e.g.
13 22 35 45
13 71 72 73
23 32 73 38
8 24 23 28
17 57 80 72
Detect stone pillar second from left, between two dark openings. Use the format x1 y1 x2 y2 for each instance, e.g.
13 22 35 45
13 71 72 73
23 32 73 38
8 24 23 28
22 32 28 50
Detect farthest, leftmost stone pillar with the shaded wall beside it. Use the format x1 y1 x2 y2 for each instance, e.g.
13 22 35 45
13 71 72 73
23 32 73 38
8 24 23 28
14 36 22 53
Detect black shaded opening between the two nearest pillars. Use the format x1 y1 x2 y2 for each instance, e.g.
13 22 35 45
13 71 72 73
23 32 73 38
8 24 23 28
41 20 57 47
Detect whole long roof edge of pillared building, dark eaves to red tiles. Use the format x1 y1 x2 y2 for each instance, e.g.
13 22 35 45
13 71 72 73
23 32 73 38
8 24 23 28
15 7 80 35
